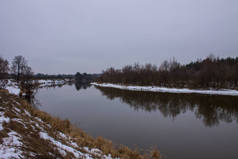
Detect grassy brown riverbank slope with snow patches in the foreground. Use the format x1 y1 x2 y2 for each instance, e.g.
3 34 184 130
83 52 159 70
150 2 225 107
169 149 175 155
0 90 160 159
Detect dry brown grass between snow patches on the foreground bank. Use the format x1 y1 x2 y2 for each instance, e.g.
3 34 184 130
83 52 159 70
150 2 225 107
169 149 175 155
0 90 161 159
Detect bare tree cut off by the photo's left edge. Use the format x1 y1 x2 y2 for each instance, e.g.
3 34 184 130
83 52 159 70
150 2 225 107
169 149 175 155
0 57 9 88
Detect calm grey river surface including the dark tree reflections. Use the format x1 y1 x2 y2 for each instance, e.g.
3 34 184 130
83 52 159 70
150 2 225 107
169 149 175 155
36 85 238 159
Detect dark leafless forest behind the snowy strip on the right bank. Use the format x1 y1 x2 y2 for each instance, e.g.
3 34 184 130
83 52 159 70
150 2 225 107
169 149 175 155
97 55 238 89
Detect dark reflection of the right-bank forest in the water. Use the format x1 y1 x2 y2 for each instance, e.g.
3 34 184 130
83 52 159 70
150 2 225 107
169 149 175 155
96 87 238 126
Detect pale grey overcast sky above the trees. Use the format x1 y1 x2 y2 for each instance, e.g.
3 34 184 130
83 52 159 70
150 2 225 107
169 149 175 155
0 0 238 74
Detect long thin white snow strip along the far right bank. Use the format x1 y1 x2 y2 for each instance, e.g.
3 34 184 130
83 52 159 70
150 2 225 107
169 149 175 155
91 83 238 96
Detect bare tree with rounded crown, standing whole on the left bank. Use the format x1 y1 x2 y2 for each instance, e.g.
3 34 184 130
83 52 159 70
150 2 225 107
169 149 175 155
11 55 29 81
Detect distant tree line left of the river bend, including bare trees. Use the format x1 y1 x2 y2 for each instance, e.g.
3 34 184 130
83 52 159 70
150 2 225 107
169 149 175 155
0 55 99 88
